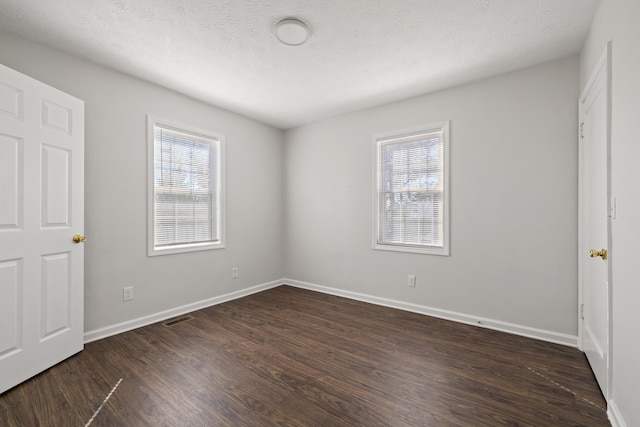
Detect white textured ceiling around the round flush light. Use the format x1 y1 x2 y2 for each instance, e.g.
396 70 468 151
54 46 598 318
0 0 599 128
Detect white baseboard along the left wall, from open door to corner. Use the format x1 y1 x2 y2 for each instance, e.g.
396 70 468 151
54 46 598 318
84 280 283 344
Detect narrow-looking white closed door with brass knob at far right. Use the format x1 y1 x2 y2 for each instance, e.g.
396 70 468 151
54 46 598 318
579 44 610 398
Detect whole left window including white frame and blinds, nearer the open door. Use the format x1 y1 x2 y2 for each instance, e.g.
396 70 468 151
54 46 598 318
147 117 224 256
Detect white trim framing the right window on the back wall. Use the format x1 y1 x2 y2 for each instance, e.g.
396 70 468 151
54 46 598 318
371 120 451 256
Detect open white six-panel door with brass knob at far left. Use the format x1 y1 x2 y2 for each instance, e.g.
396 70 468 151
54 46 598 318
0 65 84 393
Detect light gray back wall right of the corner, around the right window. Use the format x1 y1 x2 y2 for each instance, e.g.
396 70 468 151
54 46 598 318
284 57 579 345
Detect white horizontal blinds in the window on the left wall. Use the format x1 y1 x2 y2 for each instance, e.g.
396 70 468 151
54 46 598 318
154 124 220 247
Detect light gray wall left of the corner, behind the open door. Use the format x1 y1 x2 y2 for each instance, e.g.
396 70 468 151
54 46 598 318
0 33 283 338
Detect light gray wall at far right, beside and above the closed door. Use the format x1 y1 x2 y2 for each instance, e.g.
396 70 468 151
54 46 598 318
580 0 640 427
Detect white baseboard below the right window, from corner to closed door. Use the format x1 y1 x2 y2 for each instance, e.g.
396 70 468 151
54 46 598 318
282 278 578 348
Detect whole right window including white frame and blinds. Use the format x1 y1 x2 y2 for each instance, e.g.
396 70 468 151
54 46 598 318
373 122 449 255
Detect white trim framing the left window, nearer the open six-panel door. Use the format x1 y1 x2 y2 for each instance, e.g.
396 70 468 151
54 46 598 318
147 115 227 256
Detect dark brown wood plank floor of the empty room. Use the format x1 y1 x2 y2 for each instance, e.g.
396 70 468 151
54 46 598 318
0 286 609 427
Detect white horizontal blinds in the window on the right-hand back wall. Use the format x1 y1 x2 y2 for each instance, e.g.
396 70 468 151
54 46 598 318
377 130 444 247
